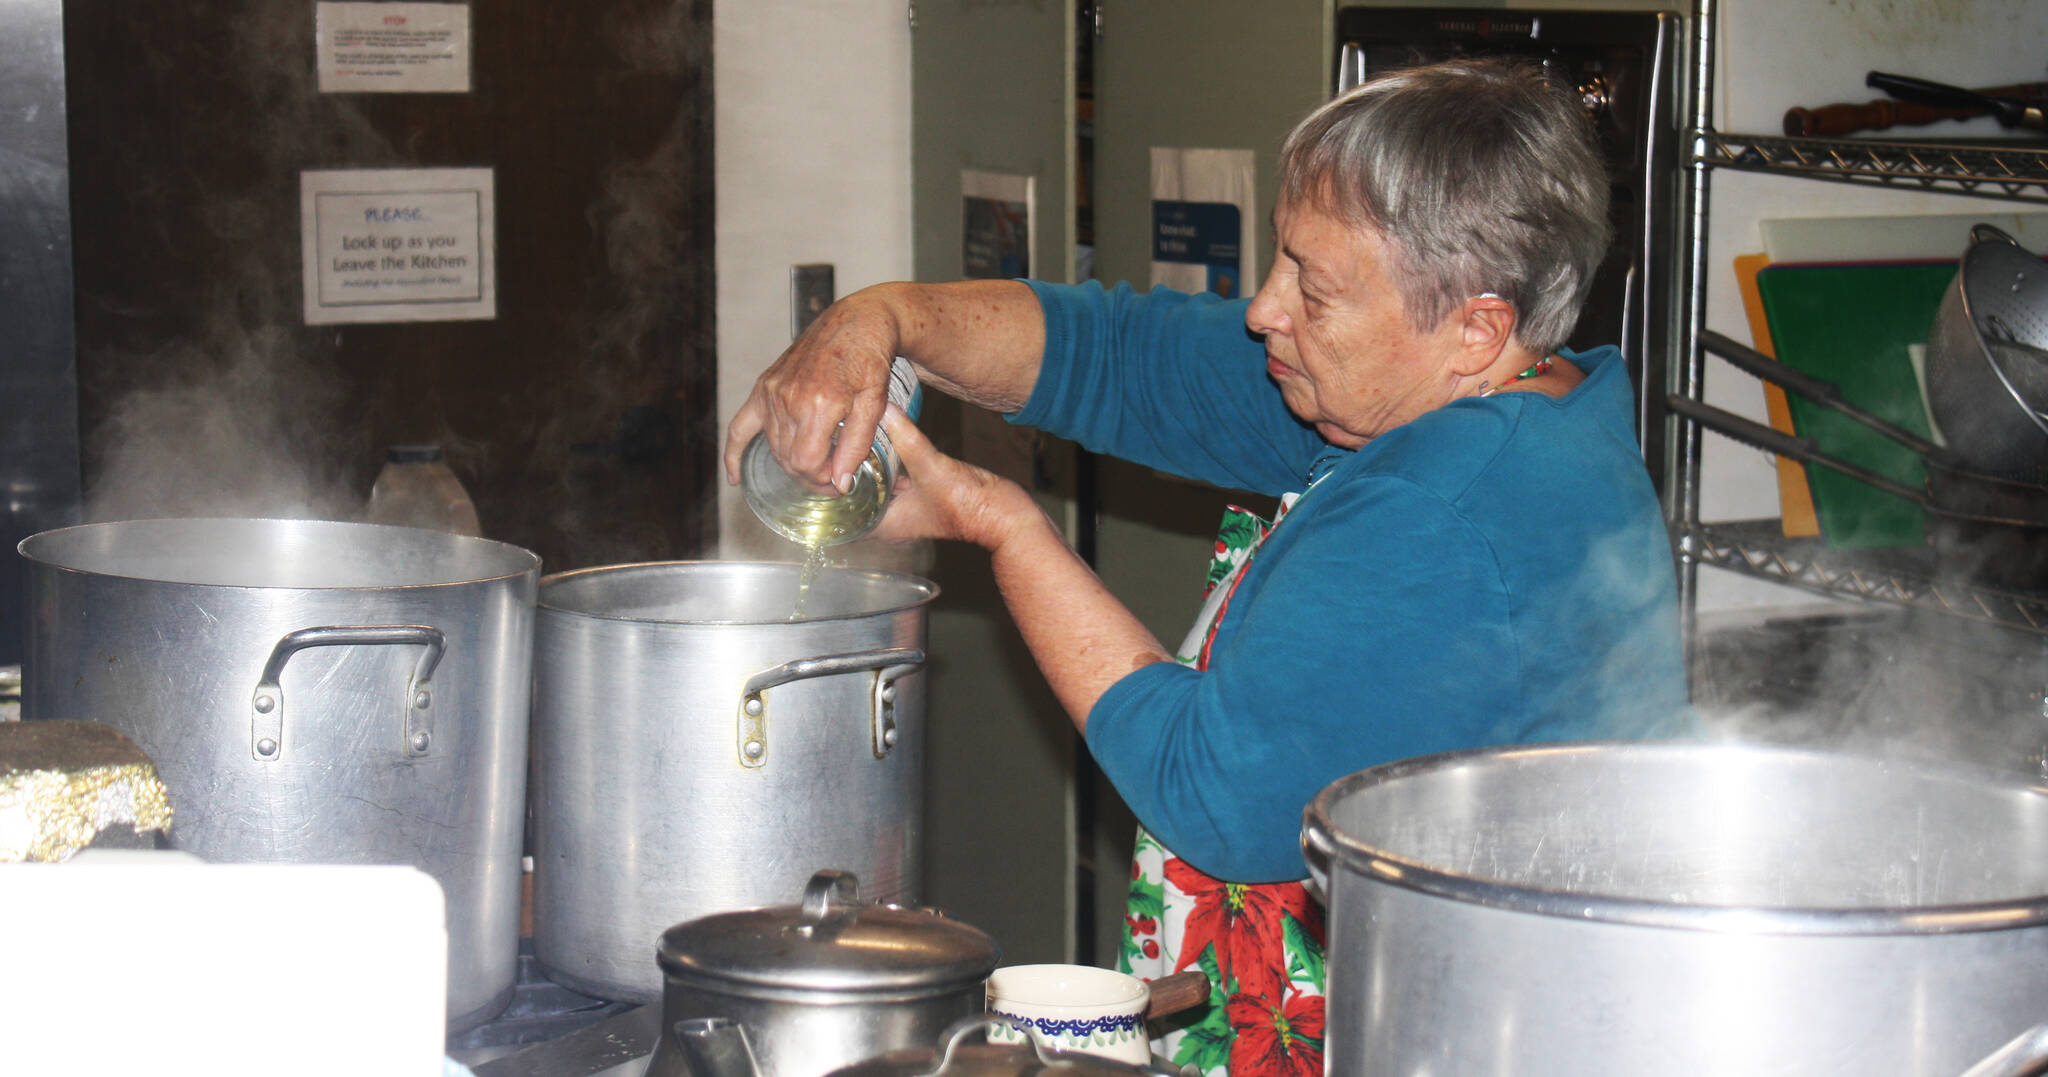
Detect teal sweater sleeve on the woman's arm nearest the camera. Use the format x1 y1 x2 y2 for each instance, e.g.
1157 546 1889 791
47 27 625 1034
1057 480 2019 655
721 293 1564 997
1087 477 1518 882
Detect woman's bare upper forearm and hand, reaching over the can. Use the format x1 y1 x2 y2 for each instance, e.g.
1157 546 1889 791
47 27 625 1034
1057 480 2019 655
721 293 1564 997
725 281 1044 491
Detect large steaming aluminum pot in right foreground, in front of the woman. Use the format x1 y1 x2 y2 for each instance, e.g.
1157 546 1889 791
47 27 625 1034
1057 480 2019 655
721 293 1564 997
1305 743 2048 1077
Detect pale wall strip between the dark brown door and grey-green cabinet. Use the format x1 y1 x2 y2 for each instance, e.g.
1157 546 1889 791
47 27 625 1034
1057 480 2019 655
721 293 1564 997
711 0 911 561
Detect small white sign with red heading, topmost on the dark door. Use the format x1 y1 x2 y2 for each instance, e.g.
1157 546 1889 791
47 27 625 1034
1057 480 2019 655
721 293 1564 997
313 2 469 94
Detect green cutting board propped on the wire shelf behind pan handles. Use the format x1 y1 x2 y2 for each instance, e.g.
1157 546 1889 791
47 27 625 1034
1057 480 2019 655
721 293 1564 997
1757 262 1956 549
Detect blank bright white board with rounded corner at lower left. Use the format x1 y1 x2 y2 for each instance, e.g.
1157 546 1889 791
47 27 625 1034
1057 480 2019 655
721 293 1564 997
0 850 449 1077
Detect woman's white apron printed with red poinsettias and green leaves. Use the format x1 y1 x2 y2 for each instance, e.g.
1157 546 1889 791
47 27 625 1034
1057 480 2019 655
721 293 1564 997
1116 493 1323 1077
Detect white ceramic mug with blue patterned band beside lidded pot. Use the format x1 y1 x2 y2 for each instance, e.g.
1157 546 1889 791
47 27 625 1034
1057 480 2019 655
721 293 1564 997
989 964 1151 1067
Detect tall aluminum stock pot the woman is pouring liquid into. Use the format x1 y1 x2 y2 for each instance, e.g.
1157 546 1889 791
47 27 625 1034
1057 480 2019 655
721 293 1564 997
532 561 938 1001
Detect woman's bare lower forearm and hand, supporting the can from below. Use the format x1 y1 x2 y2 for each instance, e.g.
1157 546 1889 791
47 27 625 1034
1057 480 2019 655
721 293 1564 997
879 412 1174 731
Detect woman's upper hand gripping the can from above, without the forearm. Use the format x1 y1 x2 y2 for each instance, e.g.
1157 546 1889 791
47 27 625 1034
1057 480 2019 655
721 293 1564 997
725 289 899 493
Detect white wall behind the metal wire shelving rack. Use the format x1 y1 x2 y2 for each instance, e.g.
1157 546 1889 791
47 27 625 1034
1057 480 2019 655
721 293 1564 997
1700 0 2048 616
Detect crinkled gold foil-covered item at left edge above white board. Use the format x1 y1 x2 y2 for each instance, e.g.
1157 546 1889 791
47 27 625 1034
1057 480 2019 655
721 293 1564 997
0 721 170 862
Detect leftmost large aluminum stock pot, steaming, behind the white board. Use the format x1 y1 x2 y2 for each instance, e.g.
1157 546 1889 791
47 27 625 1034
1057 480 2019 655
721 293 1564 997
20 520 541 1028
